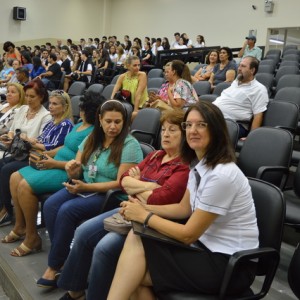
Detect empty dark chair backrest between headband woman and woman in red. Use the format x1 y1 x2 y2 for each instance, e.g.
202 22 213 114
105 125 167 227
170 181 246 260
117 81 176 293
130 108 161 147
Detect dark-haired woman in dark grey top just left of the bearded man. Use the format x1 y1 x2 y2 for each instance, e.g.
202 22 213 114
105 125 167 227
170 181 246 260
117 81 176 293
209 47 237 90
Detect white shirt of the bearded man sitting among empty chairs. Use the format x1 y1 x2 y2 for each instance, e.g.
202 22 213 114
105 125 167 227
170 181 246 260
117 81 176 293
213 79 269 121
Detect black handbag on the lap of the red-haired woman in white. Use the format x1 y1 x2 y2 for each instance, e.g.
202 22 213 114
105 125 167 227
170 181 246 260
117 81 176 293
3 129 31 161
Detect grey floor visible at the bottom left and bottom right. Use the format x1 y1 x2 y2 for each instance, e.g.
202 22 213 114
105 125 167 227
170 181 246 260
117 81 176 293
0 226 300 300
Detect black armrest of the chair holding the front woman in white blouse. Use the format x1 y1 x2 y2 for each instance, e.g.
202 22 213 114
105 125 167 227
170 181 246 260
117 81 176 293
219 247 280 300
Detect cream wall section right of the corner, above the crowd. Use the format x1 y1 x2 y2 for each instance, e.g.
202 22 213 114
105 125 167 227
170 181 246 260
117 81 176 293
112 0 300 47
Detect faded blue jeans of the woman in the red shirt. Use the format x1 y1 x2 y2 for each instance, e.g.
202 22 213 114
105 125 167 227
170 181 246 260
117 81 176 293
58 208 126 300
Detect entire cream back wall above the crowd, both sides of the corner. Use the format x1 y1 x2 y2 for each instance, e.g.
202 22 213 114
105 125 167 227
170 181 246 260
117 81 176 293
0 0 300 51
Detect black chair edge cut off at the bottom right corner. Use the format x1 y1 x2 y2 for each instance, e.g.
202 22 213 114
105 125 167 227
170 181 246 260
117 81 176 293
288 244 300 299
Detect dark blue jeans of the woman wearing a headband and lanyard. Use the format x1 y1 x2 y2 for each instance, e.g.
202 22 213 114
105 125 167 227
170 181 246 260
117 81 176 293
43 188 105 270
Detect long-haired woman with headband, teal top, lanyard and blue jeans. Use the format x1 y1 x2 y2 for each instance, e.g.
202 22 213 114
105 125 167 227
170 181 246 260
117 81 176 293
37 100 142 285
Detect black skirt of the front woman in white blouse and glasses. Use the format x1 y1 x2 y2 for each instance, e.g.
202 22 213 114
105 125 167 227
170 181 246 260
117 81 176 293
142 238 255 294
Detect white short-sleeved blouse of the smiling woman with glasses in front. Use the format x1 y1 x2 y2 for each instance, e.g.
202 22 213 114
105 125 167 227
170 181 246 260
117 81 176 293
188 160 259 255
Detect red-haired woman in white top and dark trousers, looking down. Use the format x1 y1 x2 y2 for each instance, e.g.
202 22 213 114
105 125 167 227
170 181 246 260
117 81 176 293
0 78 51 224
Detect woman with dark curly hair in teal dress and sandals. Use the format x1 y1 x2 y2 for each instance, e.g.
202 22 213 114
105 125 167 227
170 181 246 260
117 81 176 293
6 94 100 253
